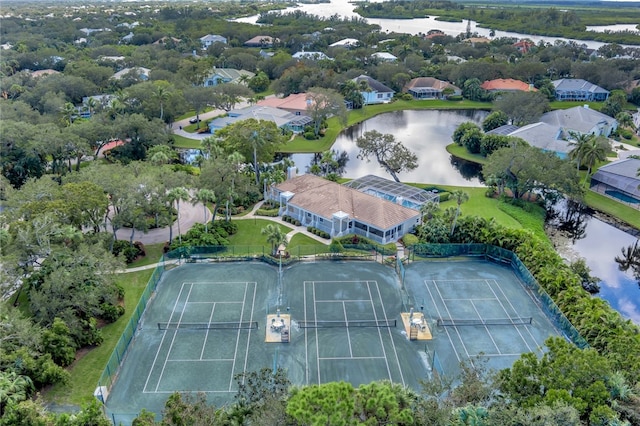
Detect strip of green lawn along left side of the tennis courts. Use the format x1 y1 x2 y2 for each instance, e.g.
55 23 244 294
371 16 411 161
44 269 153 405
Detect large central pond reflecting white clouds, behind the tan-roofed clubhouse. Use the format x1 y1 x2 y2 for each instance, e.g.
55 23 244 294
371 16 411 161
292 107 488 186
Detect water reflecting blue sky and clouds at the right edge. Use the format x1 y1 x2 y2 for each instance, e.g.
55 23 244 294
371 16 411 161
554 201 640 324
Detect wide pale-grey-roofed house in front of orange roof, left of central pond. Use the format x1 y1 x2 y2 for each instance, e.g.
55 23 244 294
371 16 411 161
209 105 313 133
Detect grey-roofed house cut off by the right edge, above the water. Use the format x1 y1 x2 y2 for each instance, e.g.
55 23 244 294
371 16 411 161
590 158 640 208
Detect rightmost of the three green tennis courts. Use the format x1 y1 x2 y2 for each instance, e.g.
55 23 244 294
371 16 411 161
405 260 559 376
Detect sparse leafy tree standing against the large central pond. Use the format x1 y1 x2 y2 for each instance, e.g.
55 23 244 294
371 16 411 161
356 130 418 182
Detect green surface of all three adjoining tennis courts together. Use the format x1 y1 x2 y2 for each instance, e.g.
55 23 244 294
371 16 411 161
107 261 558 424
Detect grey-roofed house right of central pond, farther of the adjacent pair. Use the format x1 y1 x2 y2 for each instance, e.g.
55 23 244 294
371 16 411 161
540 105 618 138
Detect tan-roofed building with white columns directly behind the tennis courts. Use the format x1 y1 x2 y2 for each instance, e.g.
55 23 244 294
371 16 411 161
268 174 421 244
